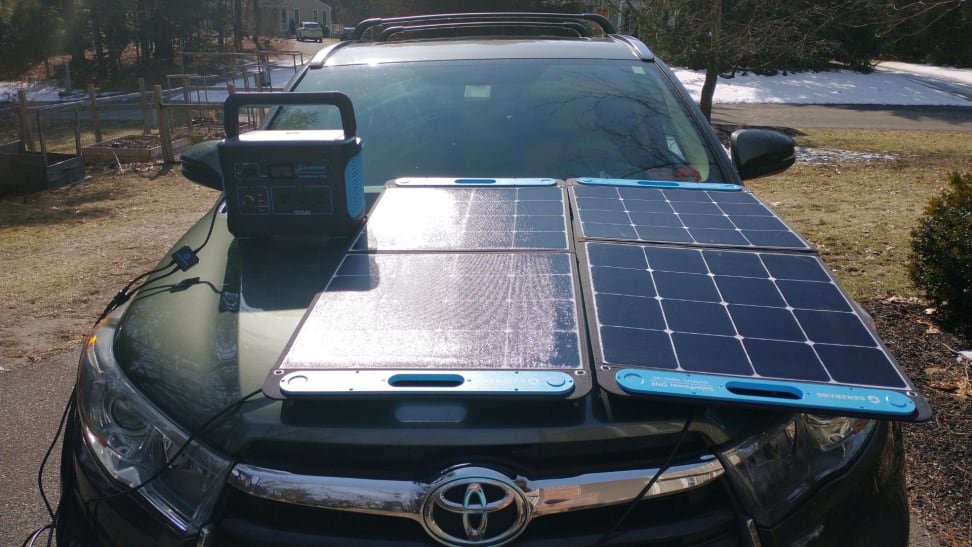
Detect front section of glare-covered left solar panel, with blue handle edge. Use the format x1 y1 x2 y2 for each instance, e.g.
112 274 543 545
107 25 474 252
265 252 590 397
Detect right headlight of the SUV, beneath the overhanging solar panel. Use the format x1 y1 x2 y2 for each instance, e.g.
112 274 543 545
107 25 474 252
723 414 876 525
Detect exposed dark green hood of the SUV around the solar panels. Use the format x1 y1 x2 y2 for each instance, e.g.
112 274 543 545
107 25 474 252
113 203 781 453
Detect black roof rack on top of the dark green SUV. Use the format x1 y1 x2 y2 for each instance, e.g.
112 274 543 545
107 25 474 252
351 12 617 42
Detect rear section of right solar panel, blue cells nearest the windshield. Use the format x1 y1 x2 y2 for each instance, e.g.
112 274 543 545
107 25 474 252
570 184 811 250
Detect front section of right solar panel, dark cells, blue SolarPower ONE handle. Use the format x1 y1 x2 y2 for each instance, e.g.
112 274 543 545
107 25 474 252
583 242 930 419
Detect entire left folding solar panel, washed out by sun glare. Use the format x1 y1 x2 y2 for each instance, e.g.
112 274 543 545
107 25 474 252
264 183 592 398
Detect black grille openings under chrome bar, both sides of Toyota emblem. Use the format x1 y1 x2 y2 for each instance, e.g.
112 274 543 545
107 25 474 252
213 479 741 547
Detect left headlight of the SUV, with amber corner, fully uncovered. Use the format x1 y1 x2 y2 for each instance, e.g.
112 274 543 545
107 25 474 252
77 326 230 532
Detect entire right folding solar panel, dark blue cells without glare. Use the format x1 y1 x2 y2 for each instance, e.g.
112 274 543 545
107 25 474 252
570 181 931 420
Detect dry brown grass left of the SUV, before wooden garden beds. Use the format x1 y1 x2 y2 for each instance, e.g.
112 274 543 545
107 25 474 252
0 165 217 368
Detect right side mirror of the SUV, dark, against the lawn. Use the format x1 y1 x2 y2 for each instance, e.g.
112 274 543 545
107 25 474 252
729 129 796 180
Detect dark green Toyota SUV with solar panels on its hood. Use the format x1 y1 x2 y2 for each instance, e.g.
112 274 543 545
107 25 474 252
57 13 928 547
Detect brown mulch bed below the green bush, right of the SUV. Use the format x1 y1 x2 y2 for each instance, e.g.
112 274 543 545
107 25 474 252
864 298 972 547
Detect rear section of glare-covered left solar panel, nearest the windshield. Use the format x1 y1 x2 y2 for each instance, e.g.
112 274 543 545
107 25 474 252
351 186 570 251
